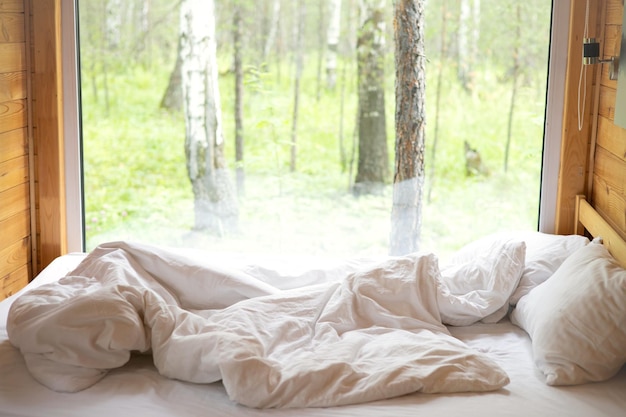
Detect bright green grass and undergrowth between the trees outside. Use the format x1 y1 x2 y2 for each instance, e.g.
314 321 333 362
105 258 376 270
83 53 545 256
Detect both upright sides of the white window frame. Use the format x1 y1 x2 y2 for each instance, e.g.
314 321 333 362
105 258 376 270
61 0 570 252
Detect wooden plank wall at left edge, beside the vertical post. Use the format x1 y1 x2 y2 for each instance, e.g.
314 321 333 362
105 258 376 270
0 0 31 299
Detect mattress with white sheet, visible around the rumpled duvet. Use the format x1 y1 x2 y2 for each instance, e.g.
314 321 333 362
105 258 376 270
0 254 626 417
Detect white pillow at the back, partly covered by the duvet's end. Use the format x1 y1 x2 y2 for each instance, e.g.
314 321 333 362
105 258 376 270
451 231 589 305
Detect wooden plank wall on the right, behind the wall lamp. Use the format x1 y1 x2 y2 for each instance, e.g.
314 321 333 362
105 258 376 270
587 0 626 236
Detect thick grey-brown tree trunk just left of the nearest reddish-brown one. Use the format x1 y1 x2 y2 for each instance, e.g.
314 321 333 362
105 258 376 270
354 0 389 195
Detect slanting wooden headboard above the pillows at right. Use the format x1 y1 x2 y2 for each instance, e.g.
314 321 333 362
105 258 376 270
575 195 626 268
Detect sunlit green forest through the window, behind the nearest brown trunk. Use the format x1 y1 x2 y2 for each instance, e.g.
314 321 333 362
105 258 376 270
78 0 551 256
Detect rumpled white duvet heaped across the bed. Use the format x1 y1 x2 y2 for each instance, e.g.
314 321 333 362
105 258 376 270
7 241 525 408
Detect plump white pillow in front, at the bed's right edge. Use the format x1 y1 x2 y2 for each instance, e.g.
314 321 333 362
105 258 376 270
511 243 626 385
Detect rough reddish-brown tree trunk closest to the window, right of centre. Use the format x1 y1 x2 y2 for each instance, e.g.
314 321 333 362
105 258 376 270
389 0 426 255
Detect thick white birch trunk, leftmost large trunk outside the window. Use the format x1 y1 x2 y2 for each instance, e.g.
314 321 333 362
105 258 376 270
180 0 238 236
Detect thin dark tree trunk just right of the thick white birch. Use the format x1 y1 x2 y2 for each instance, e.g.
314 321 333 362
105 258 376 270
233 4 245 197
